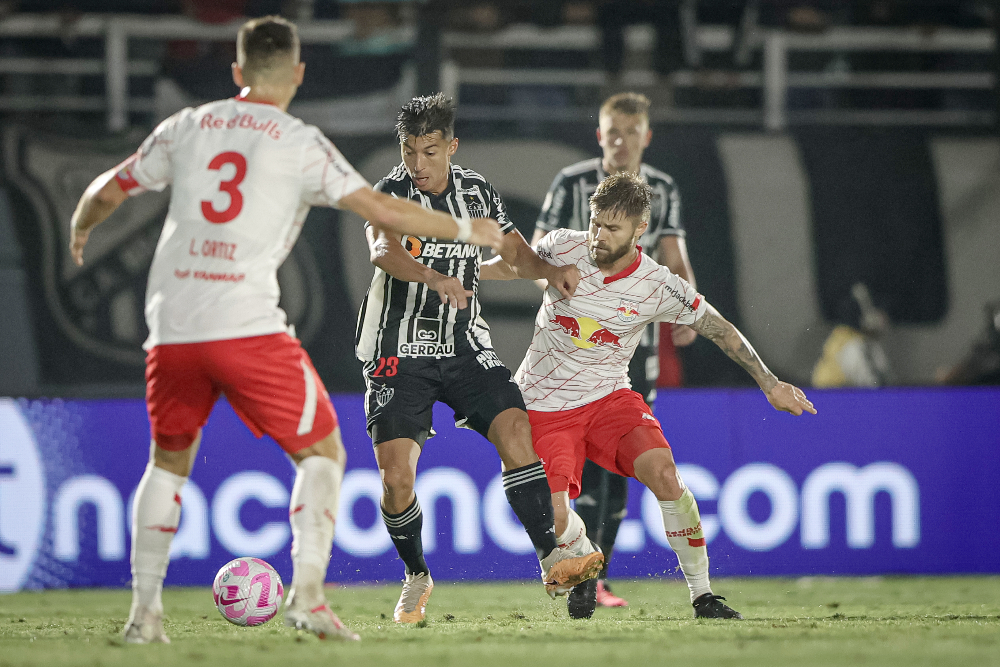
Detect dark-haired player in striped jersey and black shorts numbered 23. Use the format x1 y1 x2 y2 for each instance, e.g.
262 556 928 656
357 93 603 623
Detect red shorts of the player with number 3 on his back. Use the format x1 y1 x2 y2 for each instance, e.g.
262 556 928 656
146 333 337 452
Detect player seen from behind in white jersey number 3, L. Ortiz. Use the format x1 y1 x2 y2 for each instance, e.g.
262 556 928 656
70 17 500 643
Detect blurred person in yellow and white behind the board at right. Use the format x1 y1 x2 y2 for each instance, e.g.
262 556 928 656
812 283 889 387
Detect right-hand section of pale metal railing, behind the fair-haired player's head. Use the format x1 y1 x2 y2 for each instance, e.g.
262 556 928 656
441 26 995 130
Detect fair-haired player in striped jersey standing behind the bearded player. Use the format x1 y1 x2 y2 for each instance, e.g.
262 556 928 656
531 93 697 607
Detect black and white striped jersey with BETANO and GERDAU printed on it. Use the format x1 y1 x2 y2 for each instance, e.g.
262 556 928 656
355 164 516 362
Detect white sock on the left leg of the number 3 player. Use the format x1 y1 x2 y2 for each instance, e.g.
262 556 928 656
132 461 187 611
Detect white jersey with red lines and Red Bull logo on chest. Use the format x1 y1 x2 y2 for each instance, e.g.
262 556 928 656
515 229 706 412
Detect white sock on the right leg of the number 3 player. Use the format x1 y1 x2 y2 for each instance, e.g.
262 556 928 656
288 456 344 608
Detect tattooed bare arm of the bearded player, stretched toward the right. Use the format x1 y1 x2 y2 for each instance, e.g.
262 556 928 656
691 304 816 415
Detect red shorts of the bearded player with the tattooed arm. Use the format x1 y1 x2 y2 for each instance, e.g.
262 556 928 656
528 389 670 498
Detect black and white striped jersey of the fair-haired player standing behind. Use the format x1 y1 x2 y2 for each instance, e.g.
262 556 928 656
535 157 684 254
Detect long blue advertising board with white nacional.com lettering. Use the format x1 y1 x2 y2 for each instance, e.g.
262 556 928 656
0 389 1000 591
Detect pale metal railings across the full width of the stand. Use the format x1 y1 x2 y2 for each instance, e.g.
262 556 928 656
0 14 995 131
